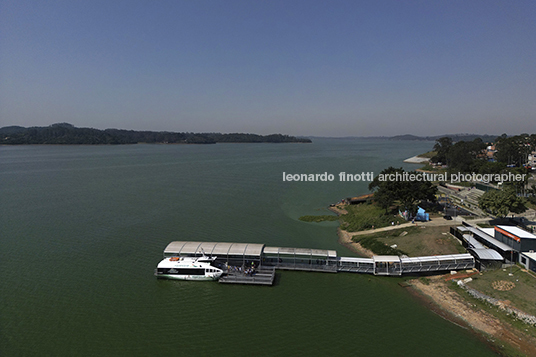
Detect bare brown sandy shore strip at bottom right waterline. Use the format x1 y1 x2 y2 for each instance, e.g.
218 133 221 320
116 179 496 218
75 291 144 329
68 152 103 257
408 276 536 356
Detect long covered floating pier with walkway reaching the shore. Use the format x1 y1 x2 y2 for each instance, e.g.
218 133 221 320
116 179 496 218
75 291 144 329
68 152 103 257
164 241 475 285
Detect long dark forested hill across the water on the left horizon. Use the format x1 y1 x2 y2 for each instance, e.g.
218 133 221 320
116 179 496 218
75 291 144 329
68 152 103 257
0 123 311 145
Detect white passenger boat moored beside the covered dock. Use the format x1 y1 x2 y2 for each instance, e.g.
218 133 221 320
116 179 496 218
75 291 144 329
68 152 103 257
155 255 223 280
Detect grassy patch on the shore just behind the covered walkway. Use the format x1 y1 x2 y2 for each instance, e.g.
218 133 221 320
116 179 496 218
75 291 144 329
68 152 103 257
354 226 466 257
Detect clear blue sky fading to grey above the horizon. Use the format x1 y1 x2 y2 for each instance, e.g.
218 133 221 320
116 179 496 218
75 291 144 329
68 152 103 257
0 0 536 136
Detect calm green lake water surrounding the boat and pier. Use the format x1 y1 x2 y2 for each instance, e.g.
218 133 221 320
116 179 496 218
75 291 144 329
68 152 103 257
0 139 493 356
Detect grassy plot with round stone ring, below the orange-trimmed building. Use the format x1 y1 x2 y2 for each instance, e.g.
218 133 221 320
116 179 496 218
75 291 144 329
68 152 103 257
467 266 536 316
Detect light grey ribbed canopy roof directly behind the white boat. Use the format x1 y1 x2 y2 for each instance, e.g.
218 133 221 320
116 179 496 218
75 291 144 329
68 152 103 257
164 241 264 257
